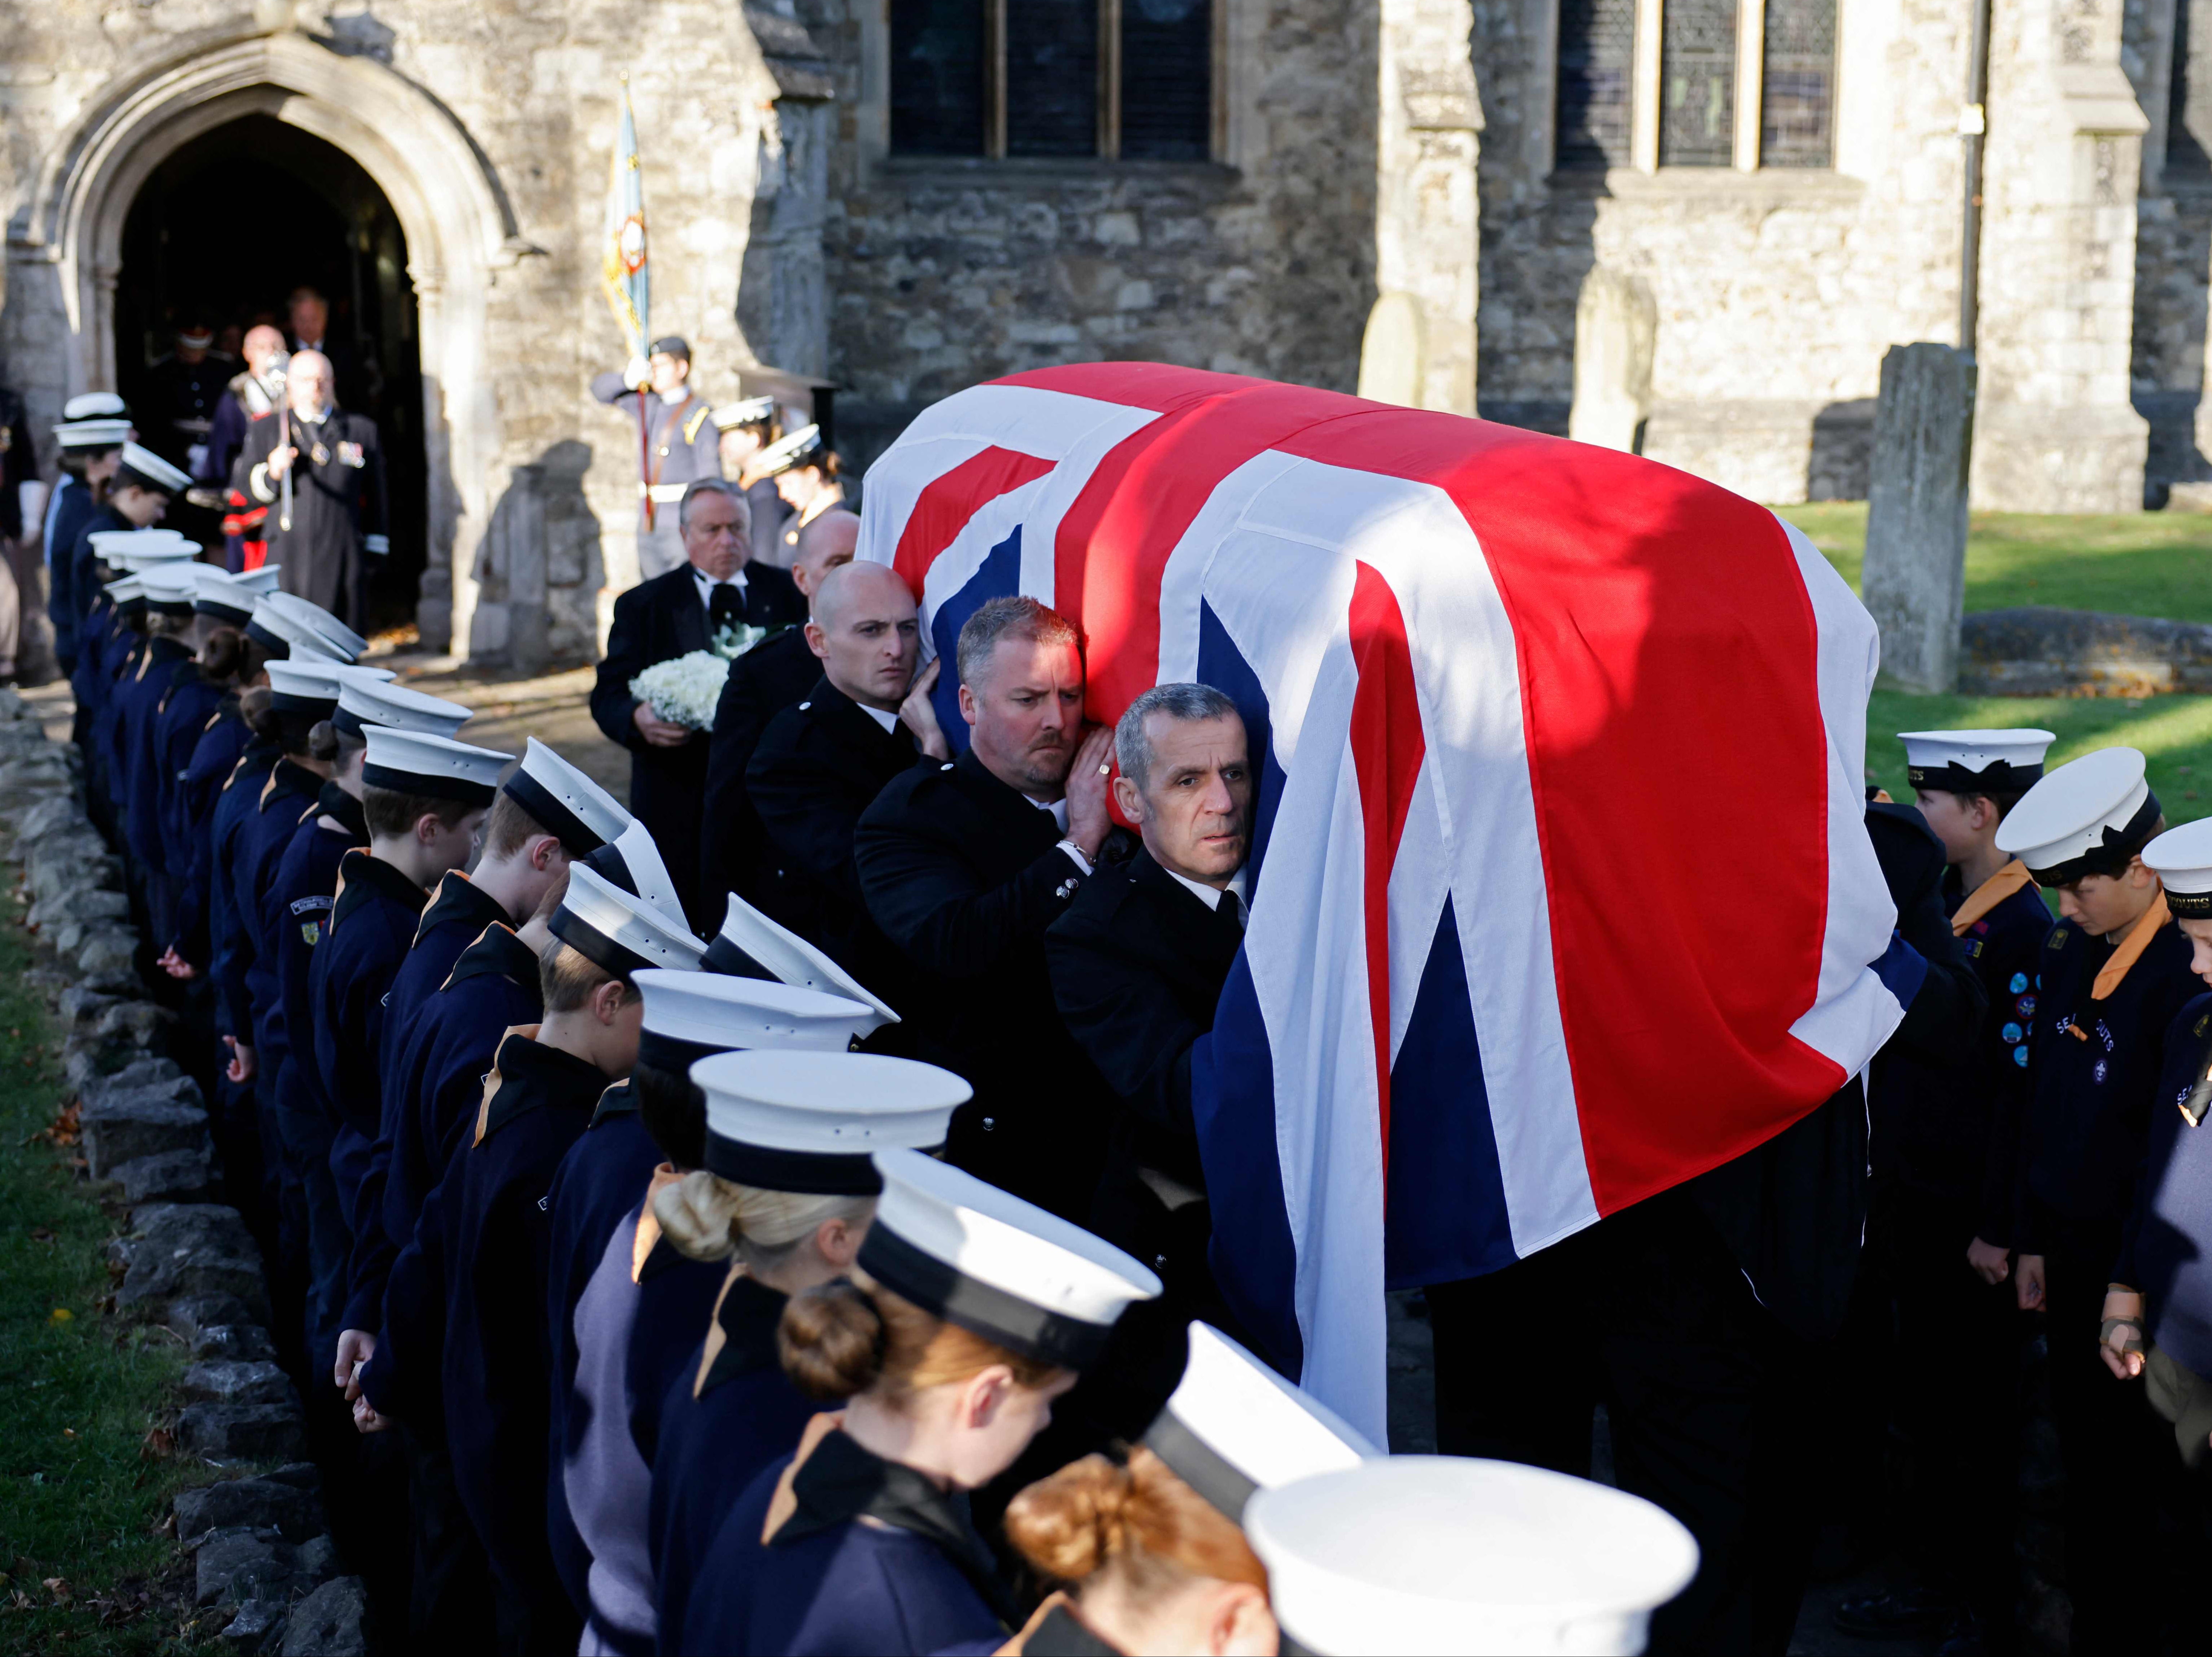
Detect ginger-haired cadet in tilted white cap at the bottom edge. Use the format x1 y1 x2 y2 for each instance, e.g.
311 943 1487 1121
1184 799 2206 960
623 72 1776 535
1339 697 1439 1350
977 1323 1380 1657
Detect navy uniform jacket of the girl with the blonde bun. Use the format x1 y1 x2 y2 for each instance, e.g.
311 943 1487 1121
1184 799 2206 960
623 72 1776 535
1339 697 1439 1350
648 1268 818 1653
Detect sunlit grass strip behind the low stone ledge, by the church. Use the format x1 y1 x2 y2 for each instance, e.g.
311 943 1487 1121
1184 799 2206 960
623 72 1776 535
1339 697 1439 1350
1781 500 2212 624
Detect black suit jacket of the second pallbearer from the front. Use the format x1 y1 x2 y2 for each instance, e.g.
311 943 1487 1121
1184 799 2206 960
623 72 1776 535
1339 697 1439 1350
854 750 1112 1221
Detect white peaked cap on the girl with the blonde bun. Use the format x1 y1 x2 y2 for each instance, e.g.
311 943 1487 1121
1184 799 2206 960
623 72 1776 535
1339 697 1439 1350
690 1048 969 1197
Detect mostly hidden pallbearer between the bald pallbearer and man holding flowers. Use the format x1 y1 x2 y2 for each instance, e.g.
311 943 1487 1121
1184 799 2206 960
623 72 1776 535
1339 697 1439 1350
699 511 858 903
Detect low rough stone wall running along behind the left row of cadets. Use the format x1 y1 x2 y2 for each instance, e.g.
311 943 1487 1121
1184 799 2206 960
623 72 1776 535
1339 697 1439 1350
0 688 367 1657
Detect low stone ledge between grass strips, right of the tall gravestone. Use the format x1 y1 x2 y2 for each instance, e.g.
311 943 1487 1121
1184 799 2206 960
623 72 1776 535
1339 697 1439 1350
1958 606 2212 697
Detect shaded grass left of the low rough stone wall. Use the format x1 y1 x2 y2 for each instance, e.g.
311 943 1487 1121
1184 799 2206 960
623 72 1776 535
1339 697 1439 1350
0 891 212 1655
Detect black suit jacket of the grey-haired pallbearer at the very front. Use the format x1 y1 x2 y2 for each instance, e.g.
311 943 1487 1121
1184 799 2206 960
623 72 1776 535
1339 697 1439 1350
1044 852 1243 1270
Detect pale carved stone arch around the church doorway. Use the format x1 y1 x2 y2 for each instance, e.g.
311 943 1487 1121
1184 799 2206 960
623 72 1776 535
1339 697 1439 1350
27 31 535 650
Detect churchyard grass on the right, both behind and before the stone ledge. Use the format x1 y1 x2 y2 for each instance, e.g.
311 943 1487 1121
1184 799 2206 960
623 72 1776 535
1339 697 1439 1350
1781 500 2212 823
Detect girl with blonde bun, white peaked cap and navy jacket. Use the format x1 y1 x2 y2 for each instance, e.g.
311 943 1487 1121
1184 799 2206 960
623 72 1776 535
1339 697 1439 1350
635 1039 969 1651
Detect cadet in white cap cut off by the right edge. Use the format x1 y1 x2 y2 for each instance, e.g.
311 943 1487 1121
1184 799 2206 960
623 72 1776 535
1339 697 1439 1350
2104 819 2212 1478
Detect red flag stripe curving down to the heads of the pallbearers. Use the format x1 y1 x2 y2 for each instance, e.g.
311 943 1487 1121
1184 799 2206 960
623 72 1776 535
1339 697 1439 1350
1048 378 1360 725
